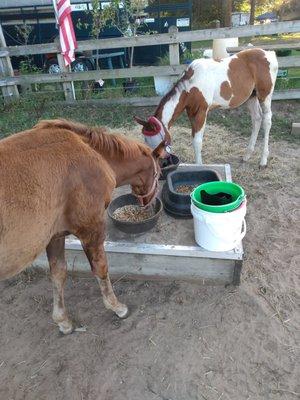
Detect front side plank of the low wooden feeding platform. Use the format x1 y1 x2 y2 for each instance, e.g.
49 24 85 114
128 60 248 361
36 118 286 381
33 249 235 284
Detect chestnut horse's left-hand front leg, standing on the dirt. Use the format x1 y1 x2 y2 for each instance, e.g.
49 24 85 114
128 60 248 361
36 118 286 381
46 237 73 334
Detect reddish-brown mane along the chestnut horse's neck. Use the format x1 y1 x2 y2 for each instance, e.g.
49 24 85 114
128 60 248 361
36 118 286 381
34 119 151 159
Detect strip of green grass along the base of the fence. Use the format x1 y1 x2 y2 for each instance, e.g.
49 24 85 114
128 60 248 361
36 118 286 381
0 94 300 142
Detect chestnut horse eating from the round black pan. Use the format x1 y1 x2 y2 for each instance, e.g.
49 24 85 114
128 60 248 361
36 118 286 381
0 120 164 334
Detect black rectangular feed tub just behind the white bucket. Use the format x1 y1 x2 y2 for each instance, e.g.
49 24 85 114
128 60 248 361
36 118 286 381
162 166 221 218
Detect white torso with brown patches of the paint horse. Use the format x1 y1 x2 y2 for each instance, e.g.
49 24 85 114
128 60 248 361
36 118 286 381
186 48 278 108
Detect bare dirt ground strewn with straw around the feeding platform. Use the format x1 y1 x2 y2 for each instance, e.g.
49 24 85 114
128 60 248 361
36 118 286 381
0 120 300 400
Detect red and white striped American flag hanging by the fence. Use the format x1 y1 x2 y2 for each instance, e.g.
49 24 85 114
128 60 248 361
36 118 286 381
53 0 77 66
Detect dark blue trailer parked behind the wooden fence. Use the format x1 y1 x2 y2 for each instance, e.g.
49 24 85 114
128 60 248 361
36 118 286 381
0 0 192 70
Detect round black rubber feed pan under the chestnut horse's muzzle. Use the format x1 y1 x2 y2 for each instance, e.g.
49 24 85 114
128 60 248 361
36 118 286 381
107 194 163 234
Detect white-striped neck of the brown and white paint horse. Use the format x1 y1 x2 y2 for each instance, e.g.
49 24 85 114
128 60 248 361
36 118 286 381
154 90 186 128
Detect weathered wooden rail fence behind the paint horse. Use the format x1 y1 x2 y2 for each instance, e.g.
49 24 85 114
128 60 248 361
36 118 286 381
0 21 300 105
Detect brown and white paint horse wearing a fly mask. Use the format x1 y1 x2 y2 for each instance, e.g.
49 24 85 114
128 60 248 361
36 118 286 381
135 49 278 166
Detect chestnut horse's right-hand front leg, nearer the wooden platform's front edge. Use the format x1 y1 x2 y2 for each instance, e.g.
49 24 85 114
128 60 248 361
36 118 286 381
80 228 128 318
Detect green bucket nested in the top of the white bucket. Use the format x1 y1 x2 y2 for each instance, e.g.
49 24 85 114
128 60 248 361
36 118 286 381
191 181 245 213
